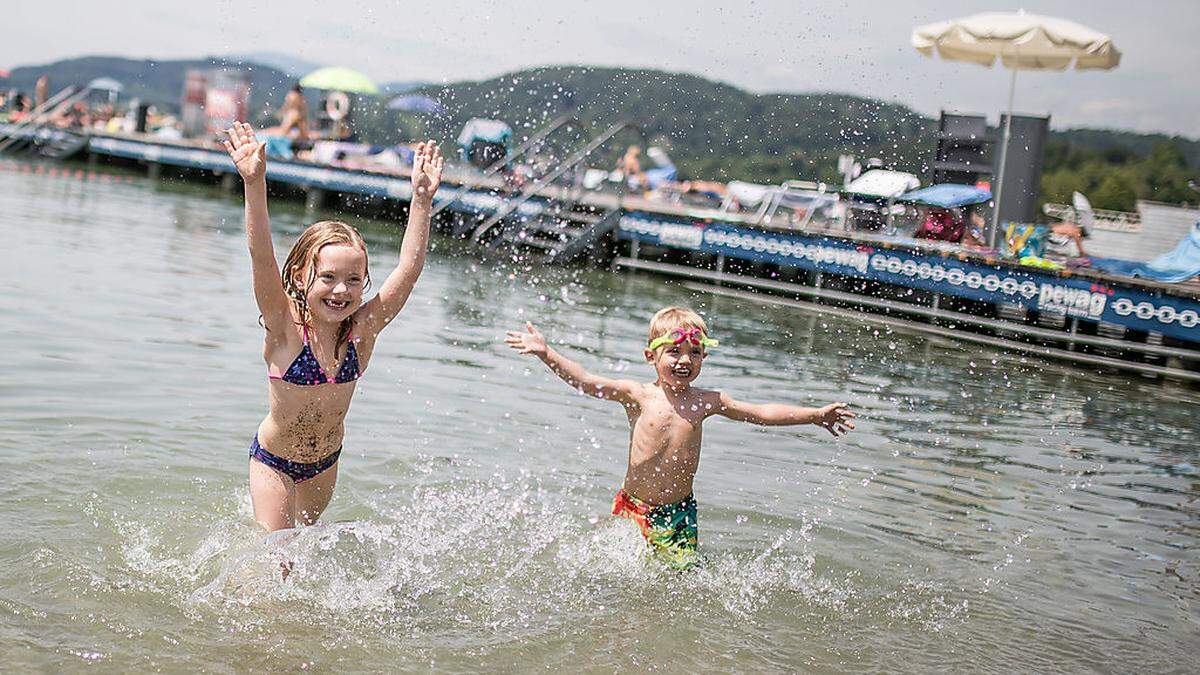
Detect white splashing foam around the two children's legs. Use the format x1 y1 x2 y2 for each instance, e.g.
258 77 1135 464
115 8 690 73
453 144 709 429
98 458 966 645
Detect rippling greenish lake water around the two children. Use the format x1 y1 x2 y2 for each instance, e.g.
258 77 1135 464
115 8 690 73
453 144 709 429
0 162 1200 673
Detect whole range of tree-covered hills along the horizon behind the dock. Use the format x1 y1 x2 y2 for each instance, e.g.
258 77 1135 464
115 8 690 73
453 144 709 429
0 56 1200 210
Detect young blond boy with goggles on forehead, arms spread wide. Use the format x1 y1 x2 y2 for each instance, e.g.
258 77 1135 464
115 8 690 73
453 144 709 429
506 307 854 568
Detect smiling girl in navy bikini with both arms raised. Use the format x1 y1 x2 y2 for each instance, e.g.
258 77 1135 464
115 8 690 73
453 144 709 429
224 123 443 530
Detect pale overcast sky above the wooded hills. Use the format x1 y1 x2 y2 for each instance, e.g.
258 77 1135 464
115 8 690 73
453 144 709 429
9 0 1200 138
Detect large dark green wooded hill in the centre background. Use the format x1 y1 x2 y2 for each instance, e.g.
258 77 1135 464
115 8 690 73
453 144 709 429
422 67 931 180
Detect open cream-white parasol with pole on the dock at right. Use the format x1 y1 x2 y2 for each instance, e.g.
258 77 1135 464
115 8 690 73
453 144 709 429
912 11 1121 235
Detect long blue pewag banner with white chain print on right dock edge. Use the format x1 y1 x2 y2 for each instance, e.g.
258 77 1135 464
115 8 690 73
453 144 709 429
618 213 1200 342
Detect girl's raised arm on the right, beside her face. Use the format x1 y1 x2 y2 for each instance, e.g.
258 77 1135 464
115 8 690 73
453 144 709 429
359 141 443 335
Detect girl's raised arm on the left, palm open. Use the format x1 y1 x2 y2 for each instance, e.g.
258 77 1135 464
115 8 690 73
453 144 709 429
224 123 292 329
